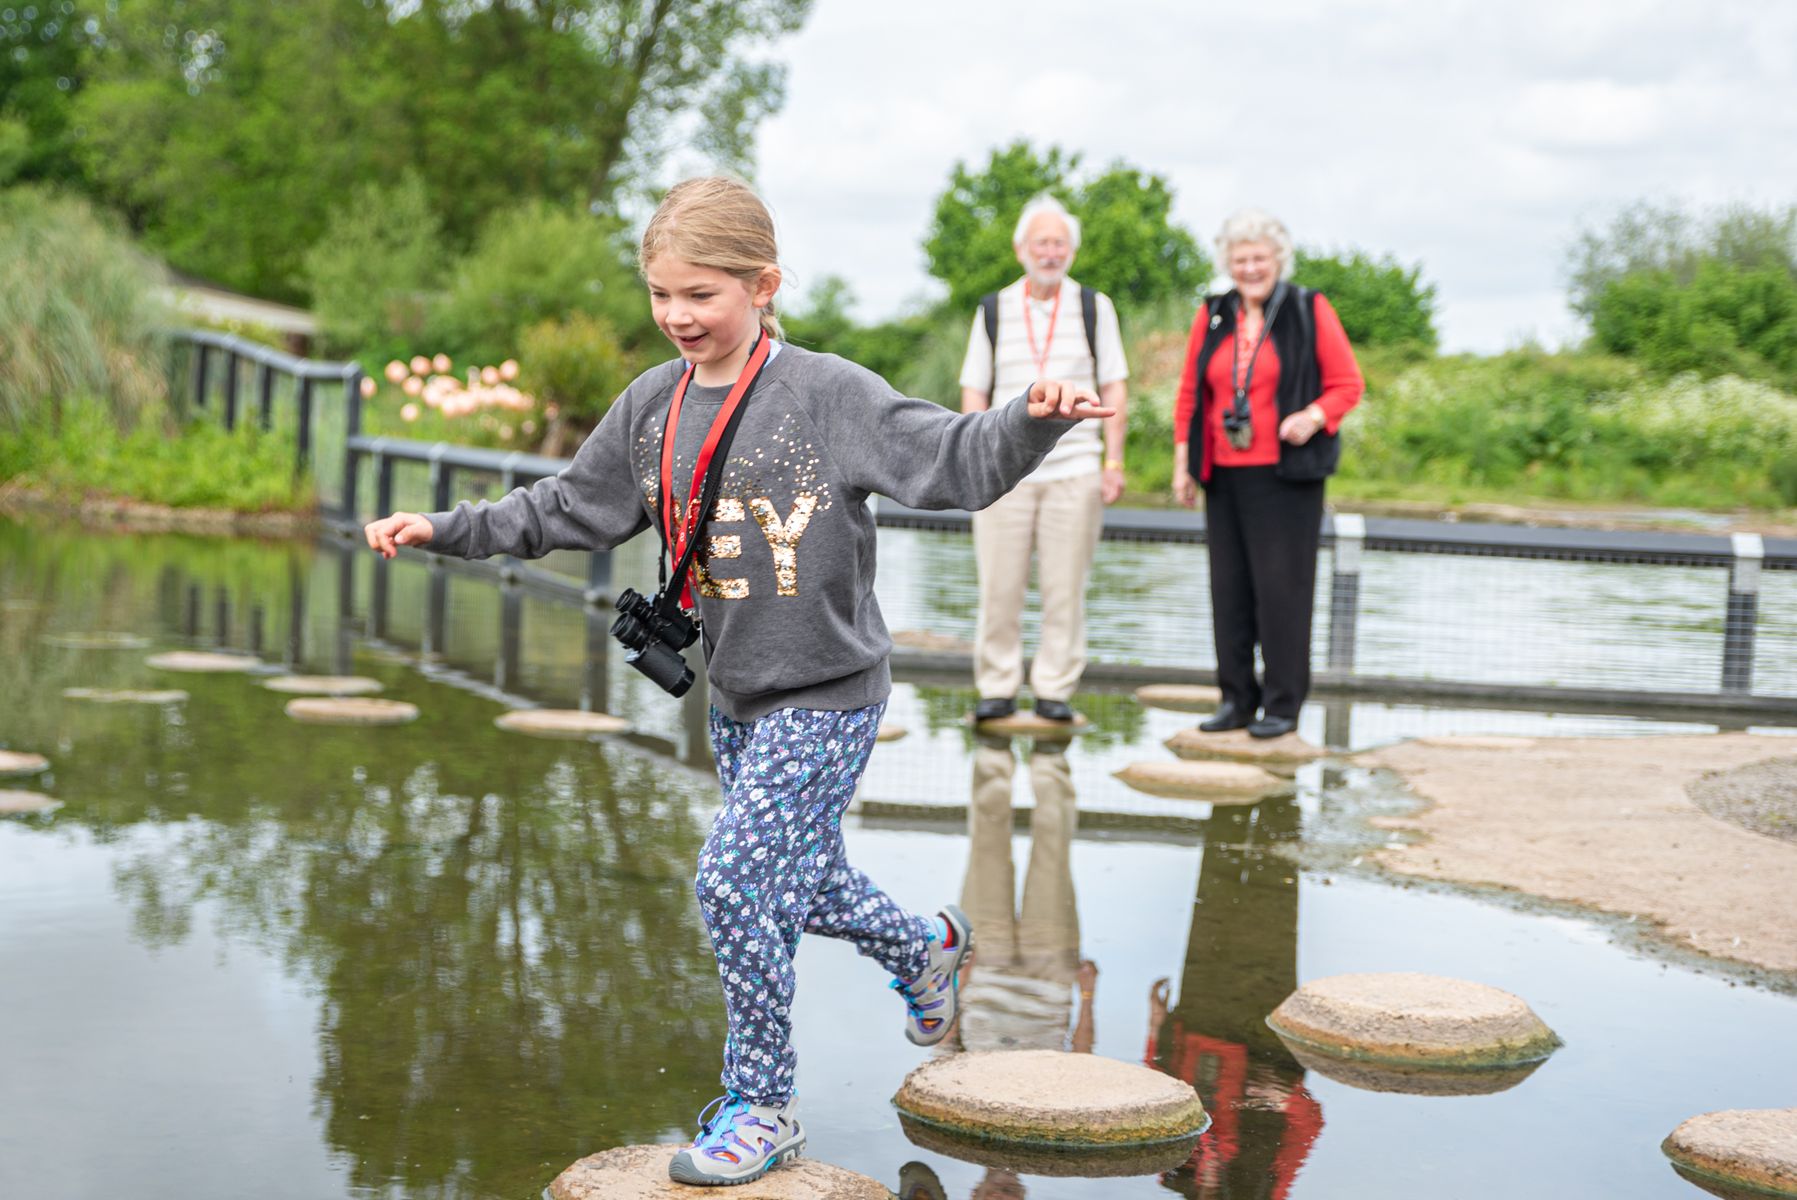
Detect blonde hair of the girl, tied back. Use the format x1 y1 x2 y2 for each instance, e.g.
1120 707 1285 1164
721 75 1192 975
636 176 785 340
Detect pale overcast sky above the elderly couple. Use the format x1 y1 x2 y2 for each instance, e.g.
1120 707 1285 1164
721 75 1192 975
757 0 1797 350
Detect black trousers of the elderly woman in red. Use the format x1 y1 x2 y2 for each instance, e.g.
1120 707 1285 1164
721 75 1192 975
1204 467 1323 719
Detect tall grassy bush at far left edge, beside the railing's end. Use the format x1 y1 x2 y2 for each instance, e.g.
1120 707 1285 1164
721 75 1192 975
0 187 165 426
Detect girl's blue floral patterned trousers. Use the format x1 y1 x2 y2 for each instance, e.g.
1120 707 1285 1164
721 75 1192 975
694 704 931 1105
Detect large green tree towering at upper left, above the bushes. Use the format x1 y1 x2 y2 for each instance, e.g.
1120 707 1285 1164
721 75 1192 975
61 0 810 296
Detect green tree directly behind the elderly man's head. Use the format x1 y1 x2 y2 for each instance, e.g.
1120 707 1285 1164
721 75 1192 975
924 142 1211 311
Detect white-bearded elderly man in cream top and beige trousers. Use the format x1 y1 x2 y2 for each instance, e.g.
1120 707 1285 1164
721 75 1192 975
961 194 1129 720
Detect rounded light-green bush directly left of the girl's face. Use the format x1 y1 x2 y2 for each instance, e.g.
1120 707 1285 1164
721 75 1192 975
429 203 661 361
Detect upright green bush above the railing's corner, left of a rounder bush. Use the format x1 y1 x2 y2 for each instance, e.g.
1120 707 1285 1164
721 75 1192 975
305 176 449 361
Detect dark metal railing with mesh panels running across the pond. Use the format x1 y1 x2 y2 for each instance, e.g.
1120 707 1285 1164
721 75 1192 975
178 334 1797 719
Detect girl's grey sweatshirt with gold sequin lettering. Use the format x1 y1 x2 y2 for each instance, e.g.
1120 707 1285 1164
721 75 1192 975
428 345 1075 720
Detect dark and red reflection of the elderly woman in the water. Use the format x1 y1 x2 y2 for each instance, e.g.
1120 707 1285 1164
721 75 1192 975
1148 798 1323 1200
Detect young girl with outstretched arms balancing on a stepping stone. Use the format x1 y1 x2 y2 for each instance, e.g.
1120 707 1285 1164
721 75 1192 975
367 178 1111 1184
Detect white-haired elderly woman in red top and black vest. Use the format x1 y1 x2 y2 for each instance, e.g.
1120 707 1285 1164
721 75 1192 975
1173 208 1366 738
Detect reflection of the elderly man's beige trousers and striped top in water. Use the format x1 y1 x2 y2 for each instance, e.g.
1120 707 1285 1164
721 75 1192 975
958 738 1098 1054
